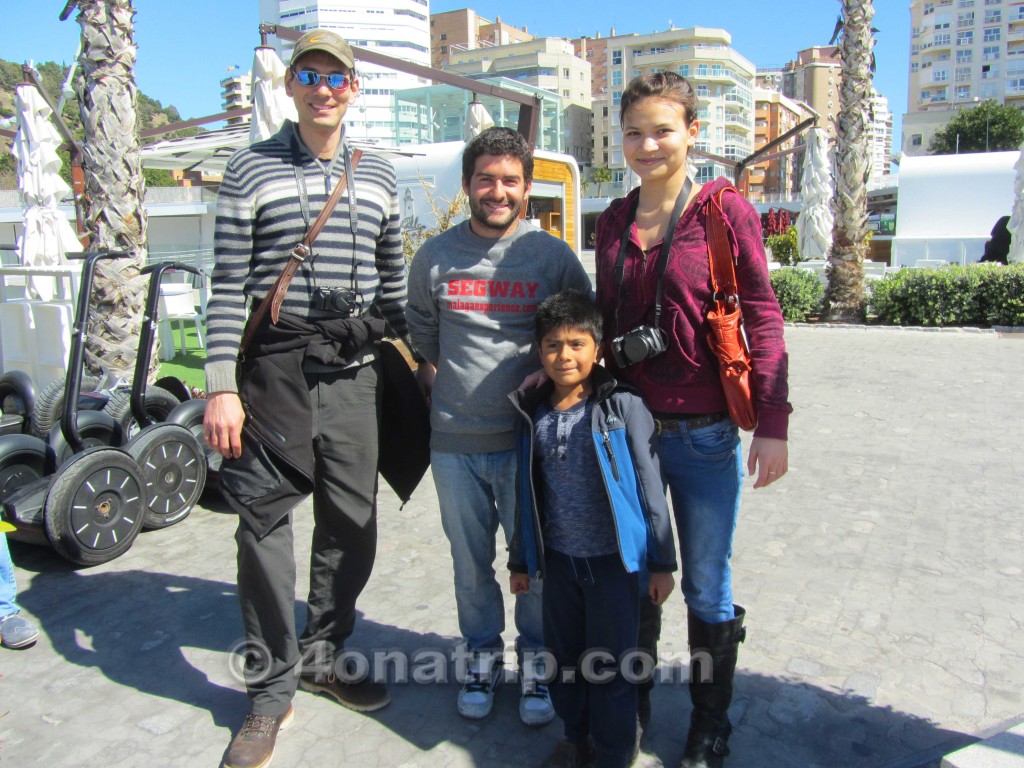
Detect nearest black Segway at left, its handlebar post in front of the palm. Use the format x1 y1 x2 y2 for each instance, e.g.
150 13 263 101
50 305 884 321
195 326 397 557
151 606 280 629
0 251 144 565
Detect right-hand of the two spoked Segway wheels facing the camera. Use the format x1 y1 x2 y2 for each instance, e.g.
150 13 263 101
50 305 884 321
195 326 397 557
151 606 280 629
127 424 206 530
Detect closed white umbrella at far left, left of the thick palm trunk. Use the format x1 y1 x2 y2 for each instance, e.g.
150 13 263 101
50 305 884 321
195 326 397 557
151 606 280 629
11 85 82 301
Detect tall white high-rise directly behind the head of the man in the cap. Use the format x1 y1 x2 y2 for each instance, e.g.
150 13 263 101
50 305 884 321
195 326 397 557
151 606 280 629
259 0 430 144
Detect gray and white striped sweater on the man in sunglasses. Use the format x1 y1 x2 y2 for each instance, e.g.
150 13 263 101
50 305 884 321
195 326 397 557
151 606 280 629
206 123 408 392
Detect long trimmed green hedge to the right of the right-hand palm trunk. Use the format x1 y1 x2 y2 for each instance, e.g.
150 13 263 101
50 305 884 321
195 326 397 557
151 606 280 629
868 264 1024 328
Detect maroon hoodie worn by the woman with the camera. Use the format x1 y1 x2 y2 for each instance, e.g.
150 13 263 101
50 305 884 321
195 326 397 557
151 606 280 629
596 178 793 439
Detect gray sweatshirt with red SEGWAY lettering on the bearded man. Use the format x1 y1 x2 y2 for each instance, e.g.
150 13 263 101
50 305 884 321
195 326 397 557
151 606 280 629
406 221 591 454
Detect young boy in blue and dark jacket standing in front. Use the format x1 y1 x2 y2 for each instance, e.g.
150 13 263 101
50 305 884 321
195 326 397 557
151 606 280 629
509 291 676 768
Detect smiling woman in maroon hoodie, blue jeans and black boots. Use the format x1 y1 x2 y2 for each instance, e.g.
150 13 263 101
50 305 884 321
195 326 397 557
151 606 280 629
597 73 792 768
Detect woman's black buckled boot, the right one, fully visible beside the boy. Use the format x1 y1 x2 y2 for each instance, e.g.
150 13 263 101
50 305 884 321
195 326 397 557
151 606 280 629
680 605 746 768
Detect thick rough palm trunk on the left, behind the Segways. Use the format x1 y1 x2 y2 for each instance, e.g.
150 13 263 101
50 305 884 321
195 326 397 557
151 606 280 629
78 0 146 374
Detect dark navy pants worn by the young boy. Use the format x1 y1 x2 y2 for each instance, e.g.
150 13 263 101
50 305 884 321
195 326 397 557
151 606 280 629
543 550 640 768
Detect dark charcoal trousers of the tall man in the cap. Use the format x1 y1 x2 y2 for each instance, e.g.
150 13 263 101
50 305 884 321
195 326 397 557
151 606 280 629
232 362 380 715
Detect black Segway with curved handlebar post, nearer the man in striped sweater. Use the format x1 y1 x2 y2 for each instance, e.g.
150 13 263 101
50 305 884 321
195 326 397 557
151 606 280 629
118 263 206 529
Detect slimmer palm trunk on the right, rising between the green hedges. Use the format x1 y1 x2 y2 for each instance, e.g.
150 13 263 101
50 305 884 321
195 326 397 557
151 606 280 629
825 0 874 322
